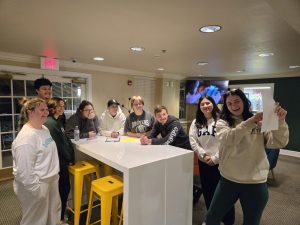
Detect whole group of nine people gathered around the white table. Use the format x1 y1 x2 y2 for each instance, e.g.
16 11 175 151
12 78 289 225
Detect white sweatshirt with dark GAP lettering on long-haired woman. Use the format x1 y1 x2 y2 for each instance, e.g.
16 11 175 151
189 118 219 164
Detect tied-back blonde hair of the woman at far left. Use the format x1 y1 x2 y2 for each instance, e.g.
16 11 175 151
18 97 46 131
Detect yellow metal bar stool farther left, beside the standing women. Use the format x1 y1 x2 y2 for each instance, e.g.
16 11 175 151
69 161 100 225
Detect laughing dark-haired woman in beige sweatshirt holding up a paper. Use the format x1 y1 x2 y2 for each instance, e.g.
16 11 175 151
206 89 289 225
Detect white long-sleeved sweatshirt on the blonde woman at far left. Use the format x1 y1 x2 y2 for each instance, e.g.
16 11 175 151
12 124 59 192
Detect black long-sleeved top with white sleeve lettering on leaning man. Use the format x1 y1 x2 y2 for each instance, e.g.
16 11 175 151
149 115 191 149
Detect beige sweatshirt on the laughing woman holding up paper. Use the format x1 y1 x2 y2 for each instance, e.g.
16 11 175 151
217 117 289 184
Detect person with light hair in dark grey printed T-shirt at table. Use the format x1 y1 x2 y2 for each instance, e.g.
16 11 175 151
124 96 155 138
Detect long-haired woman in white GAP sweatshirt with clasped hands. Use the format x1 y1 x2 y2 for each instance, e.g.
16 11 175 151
189 96 235 225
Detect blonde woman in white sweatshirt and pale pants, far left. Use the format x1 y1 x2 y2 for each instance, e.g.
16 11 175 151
12 98 61 225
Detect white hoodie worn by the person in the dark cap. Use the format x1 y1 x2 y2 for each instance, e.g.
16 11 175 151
100 107 126 137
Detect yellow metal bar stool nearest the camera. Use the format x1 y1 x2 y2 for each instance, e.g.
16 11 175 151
86 175 123 225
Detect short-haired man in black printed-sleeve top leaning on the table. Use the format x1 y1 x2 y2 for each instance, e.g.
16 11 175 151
140 105 191 150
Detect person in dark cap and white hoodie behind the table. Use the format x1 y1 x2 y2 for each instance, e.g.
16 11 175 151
100 99 126 138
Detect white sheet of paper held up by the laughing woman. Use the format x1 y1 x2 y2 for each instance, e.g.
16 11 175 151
261 90 278 132
